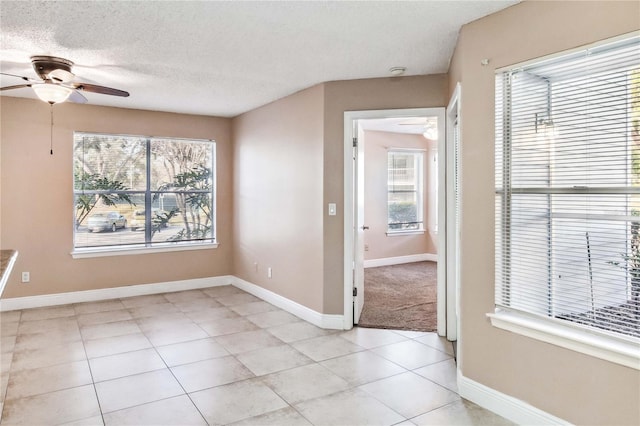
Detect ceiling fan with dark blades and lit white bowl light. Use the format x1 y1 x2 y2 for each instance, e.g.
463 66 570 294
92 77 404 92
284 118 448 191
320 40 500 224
0 56 129 105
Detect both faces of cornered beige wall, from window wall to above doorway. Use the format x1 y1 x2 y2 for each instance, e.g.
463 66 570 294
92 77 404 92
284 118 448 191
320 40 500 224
233 75 448 314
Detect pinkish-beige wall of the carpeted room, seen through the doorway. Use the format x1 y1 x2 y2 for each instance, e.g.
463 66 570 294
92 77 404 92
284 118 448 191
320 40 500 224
362 130 436 260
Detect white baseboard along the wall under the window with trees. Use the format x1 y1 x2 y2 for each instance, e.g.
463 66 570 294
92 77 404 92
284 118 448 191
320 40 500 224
0 275 233 312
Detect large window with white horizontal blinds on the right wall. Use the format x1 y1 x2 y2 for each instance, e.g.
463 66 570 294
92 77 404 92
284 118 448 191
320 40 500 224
495 37 640 350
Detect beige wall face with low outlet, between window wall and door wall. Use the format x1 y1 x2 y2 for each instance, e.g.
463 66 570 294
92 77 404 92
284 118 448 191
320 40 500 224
233 85 326 312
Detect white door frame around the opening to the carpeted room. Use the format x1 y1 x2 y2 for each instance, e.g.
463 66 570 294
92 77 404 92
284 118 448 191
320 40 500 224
343 107 447 330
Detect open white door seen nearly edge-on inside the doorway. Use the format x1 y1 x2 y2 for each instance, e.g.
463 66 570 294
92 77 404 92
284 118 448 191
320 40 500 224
353 120 369 324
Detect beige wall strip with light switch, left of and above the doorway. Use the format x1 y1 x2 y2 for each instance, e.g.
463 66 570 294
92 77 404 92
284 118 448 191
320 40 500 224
323 74 448 314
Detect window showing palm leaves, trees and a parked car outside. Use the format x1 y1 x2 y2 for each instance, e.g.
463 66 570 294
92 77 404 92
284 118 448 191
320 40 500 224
73 132 215 253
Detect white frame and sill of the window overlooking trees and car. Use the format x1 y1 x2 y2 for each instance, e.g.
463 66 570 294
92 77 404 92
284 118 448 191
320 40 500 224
71 132 219 259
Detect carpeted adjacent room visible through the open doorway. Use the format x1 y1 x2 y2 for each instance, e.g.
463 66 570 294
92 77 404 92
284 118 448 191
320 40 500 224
356 116 444 332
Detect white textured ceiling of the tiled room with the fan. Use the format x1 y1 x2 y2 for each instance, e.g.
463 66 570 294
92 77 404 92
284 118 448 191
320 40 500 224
0 0 518 117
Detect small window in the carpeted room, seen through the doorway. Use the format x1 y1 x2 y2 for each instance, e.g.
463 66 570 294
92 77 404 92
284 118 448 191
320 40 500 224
387 150 424 234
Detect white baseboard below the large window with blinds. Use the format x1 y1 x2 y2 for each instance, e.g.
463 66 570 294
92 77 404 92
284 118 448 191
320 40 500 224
458 370 571 426
